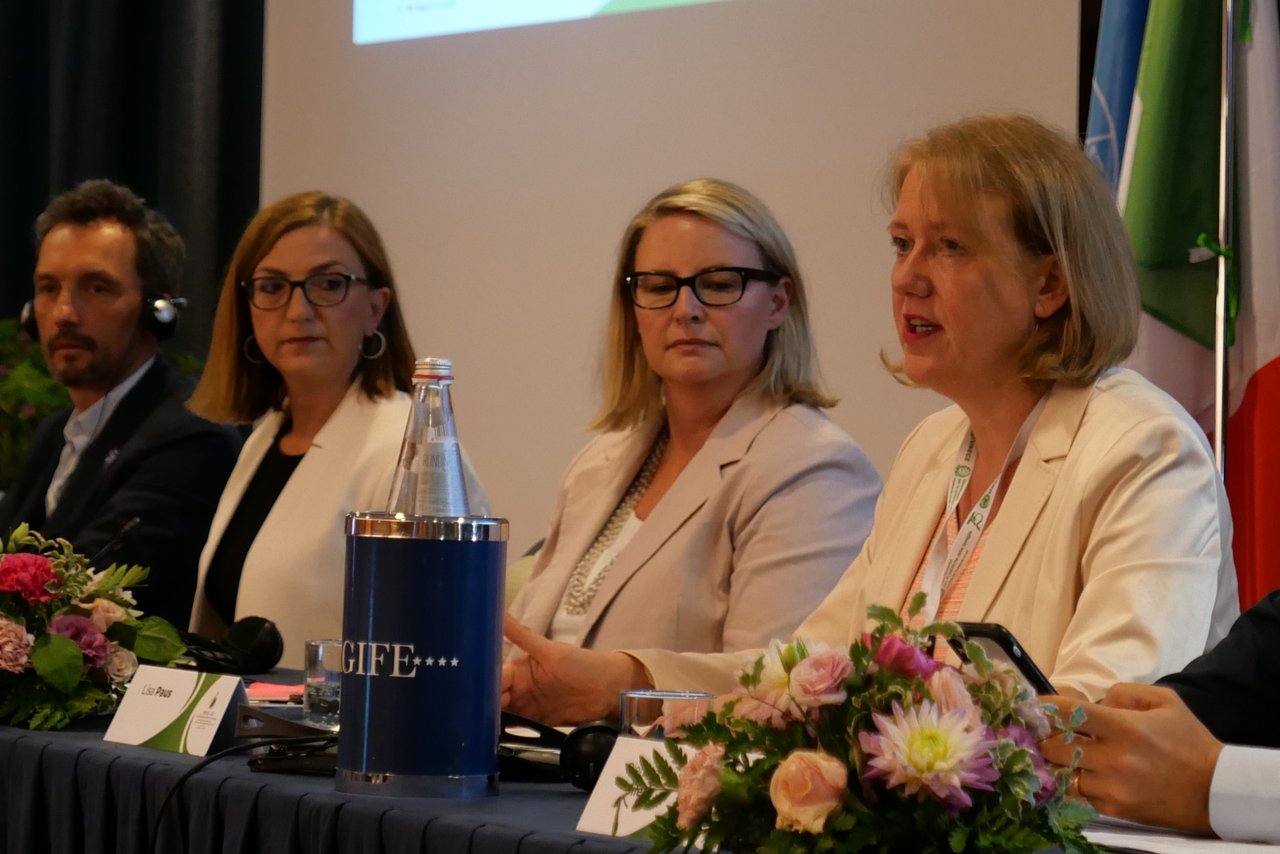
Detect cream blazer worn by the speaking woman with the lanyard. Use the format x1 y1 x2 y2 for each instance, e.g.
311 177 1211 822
632 369 1239 699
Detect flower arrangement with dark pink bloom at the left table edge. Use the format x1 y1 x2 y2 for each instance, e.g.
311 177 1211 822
0 524 186 730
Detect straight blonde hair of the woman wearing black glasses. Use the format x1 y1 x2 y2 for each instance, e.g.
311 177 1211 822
590 178 836 430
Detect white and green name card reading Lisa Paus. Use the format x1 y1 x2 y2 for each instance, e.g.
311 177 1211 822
102 665 248 757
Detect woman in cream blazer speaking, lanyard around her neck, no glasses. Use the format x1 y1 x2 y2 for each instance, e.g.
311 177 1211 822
503 115 1238 721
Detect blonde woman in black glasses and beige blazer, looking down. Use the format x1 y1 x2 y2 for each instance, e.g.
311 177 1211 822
512 179 879 652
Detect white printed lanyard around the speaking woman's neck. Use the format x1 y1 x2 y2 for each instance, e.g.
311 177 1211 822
920 397 1048 622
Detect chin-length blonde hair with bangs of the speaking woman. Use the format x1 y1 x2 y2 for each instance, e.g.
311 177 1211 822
886 114 1142 385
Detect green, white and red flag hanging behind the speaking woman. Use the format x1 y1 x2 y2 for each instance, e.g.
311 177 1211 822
1111 0 1280 607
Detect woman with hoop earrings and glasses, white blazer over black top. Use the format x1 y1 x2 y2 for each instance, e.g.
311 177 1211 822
188 192 488 667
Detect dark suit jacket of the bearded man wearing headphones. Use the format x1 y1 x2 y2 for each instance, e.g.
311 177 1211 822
0 356 241 629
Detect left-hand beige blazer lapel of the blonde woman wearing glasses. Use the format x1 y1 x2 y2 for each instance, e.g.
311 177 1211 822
525 421 662 634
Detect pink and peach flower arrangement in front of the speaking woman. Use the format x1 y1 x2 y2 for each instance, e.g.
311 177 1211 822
617 594 1097 853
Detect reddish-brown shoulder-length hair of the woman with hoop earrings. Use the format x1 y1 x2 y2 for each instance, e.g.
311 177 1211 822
187 189 413 424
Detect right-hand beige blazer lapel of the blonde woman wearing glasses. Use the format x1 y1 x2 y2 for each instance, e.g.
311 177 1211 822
579 396 781 643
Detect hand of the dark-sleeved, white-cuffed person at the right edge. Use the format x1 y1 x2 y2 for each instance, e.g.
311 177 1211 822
1041 684 1222 834
